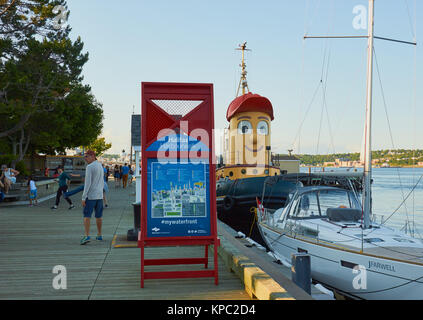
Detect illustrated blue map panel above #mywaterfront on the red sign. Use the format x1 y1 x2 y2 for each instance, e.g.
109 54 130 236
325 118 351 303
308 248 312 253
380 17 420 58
150 162 207 218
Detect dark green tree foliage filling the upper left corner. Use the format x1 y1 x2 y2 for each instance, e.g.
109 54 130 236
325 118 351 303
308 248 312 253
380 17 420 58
0 0 103 160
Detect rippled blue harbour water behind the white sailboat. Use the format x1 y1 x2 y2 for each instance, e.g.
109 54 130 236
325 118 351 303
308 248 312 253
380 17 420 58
301 167 423 239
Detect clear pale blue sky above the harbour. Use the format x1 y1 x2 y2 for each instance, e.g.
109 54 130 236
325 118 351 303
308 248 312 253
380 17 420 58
68 0 423 154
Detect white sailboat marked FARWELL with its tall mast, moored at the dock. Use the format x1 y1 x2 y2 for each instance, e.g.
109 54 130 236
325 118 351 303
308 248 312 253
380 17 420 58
258 0 423 300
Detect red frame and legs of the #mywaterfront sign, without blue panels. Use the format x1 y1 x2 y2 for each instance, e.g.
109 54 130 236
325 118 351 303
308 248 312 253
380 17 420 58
138 82 220 288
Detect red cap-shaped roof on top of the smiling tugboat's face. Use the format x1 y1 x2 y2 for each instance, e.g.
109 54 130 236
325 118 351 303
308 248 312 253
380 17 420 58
226 92 274 121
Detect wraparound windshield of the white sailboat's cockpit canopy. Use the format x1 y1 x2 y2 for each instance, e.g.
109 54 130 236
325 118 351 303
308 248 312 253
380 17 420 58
290 189 360 219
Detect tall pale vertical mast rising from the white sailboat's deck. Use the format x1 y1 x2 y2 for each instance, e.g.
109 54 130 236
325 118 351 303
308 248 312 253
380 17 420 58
363 0 375 229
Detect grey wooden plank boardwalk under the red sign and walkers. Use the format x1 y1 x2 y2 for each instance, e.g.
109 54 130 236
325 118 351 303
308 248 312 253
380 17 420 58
0 181 249 300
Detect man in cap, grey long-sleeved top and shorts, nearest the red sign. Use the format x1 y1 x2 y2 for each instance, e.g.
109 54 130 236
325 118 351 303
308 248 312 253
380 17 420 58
80 150 104 245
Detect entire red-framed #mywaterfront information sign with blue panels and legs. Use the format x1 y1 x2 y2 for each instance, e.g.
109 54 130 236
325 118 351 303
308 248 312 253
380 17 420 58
138 83 219 287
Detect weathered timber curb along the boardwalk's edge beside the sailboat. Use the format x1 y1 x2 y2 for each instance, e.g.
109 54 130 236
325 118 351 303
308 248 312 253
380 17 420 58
217 236 295 300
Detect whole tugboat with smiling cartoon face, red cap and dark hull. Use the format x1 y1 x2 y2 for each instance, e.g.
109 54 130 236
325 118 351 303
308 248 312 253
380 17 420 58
216 43 362 248
